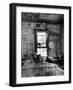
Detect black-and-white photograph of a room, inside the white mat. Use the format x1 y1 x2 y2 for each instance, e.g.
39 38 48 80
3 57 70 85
21 12 64 77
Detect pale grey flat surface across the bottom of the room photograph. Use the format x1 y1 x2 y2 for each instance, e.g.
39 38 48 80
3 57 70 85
21 62 64 77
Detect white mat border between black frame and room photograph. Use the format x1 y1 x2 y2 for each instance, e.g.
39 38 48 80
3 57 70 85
16 7 69 84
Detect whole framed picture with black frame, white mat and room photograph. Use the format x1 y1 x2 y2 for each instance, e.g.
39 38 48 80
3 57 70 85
10 3 71 86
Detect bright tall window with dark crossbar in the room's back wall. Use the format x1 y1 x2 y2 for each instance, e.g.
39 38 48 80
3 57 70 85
37 32 47 56
